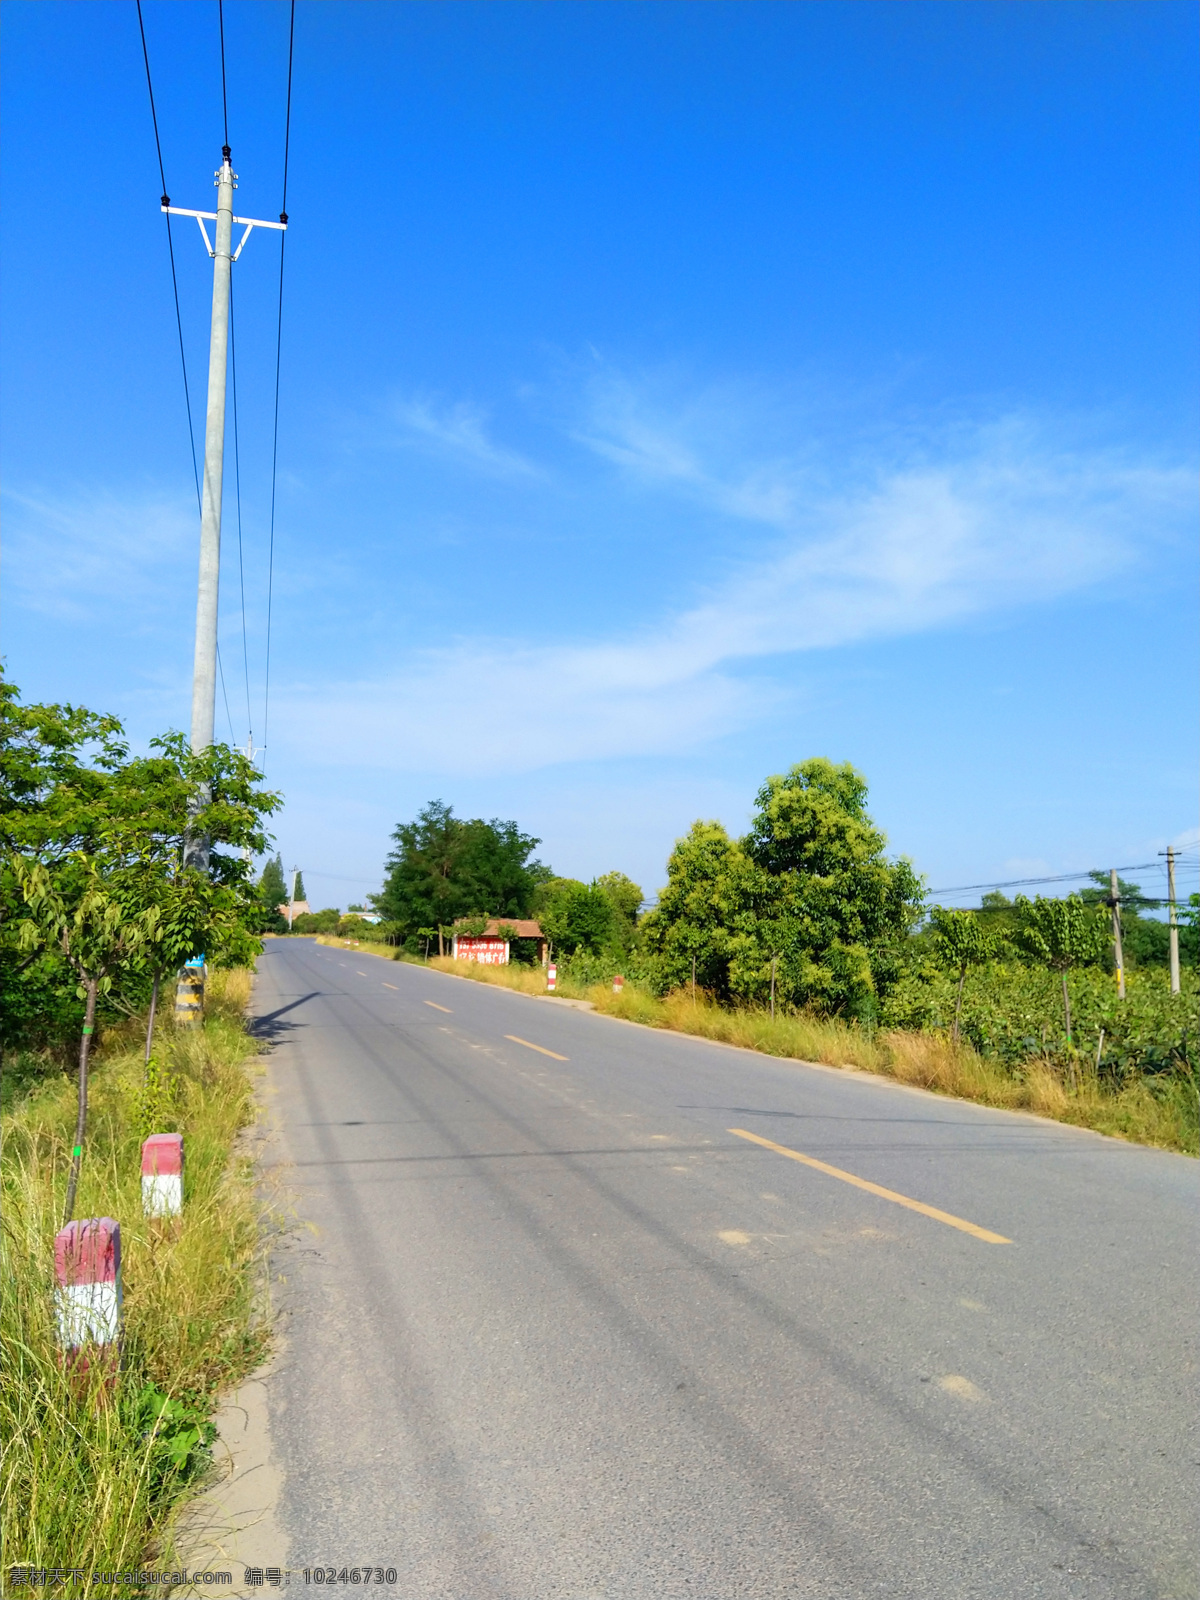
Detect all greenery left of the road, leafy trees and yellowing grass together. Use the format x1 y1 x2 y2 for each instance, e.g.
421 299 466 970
0 678 278 1595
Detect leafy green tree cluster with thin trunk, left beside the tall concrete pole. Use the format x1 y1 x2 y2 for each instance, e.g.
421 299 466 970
0 683 278 1205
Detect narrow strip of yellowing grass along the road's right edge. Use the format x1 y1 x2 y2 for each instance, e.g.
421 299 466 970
421 957 1200 1155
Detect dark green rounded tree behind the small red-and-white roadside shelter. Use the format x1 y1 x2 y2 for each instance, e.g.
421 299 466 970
374 800 542 954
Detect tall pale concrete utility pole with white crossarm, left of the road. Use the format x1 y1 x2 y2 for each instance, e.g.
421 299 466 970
162 144 288 872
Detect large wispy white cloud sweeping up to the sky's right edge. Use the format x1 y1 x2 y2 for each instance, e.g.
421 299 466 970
277 382 1194 773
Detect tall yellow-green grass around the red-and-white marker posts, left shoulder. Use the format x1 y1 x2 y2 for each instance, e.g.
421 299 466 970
0 971 267 1595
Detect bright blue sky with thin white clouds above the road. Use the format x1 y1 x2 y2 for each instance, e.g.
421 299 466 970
2 0 1198 904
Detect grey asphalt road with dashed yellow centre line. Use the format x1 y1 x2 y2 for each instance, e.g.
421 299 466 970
256 939 1200 1600
